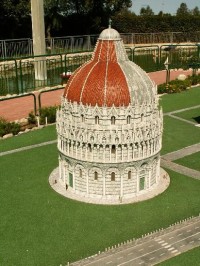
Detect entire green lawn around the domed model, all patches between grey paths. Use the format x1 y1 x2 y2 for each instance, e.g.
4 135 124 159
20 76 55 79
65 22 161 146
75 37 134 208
0 87 200 266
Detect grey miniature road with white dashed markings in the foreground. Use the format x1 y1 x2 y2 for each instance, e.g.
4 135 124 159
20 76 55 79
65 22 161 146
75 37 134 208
70 217 200 266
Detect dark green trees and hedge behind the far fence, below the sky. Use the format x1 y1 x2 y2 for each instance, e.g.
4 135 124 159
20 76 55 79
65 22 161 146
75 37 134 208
0 0 200 39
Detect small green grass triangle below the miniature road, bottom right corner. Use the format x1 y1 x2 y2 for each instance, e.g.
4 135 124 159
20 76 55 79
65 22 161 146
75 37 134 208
157 247 200 266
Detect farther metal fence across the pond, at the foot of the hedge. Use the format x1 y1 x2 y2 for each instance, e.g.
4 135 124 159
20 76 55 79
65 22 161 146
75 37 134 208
0 31 200 59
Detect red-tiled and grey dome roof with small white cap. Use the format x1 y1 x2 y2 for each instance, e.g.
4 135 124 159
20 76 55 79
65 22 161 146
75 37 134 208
64 27 156 107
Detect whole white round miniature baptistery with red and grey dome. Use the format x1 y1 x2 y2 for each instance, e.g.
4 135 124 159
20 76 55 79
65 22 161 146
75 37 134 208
57 26 163 201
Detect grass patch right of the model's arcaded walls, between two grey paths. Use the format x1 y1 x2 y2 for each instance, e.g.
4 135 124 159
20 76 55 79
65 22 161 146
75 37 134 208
161 116 200 155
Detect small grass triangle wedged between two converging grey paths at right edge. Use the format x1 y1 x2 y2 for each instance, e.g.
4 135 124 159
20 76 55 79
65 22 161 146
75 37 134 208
174 152 200 171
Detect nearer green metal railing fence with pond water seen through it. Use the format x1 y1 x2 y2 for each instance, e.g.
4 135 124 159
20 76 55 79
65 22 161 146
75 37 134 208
0 44 200 95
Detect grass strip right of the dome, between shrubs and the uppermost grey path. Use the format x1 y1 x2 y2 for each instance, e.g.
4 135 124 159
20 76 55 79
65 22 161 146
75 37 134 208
160 87 200 113
